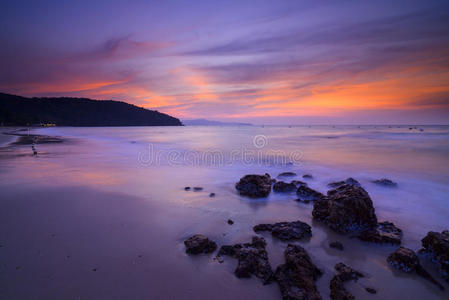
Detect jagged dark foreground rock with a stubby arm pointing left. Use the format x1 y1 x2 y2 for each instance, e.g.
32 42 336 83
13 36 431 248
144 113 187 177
217 236 274 284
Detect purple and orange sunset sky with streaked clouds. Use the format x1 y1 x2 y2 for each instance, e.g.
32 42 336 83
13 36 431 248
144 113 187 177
0 0 449 124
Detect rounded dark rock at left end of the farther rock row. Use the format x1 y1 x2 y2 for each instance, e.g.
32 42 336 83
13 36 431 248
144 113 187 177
235 173 271 198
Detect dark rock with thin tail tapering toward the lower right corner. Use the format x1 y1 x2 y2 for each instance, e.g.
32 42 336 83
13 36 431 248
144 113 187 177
387 247 444 290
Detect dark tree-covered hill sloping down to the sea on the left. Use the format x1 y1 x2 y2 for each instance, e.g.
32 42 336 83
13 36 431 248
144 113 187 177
0 93 182 126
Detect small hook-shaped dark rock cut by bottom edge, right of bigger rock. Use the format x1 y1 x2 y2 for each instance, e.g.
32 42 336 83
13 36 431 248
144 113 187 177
330 263 364 300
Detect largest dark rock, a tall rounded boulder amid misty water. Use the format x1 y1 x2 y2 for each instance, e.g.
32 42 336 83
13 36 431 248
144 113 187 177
312 184 377 233
